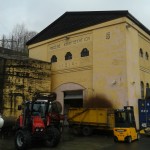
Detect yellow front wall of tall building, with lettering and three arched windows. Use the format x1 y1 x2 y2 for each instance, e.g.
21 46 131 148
29 19 128 108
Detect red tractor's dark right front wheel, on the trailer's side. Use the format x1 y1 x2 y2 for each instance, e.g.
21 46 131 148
45 127 61 147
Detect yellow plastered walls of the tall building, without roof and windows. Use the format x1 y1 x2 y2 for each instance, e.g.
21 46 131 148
29 17 150 127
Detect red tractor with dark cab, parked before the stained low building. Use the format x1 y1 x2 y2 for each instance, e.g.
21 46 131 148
15 93 64 150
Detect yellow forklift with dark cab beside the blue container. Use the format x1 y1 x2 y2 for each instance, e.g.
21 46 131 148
113 106 140 143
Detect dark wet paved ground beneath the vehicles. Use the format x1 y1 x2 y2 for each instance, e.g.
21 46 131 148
0 128 150 150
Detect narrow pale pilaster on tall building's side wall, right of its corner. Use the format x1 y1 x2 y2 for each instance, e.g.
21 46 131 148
126 22 141 127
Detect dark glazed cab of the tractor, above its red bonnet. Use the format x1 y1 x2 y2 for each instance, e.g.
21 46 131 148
18 93 62 125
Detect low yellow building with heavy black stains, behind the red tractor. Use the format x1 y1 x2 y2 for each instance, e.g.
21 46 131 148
0 49 51 118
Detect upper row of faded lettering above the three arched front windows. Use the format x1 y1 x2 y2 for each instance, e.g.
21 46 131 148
49 36 91 50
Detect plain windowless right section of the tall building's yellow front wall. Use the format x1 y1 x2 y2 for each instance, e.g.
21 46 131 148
93 24 127 108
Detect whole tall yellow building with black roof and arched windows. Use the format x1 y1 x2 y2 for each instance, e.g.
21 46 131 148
27 11 150 127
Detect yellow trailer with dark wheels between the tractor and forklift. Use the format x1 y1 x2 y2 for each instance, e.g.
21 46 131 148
68 108 115 136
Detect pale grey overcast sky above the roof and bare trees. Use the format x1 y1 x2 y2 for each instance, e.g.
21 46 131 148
0 0 150 38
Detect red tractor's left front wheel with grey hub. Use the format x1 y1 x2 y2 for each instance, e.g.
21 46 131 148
15 130 31 150
